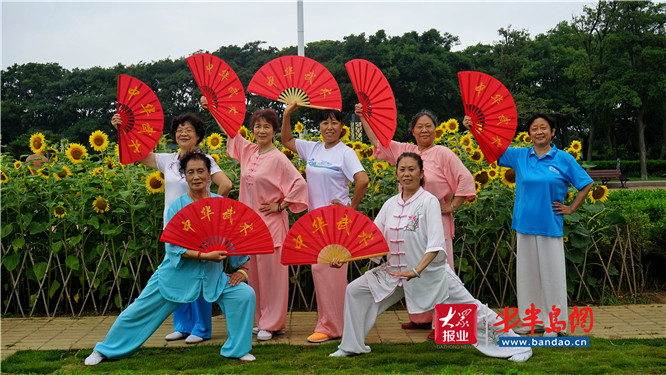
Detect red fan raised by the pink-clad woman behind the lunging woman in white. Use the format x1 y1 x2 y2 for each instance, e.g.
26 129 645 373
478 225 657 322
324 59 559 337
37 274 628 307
345 59 398 147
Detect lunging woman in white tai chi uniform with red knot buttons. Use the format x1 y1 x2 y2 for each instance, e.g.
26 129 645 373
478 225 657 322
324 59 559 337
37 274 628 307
331 153 532 362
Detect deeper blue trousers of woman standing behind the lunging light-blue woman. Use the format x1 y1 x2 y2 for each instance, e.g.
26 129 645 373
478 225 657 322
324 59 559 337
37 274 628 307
173 297 213 339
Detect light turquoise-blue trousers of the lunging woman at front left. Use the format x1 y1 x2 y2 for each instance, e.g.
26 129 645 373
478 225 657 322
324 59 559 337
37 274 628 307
95 277 256 358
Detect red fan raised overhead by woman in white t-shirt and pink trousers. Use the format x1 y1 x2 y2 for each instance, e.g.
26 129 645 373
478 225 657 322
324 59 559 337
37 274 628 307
247 56 342 111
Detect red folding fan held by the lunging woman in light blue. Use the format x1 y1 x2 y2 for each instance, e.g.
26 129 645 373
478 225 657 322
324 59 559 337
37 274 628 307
160 197 274 255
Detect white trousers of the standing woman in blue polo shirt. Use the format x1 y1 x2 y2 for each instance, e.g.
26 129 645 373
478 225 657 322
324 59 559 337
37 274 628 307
516 233 569 332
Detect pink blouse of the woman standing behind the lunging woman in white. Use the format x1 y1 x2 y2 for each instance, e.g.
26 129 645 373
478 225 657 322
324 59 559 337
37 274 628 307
374 141 476 238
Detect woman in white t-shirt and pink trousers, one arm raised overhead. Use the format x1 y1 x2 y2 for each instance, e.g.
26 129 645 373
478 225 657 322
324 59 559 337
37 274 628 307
281 103 370 342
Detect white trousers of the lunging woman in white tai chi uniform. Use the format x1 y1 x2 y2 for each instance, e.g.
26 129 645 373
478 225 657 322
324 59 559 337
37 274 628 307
338 267 532 358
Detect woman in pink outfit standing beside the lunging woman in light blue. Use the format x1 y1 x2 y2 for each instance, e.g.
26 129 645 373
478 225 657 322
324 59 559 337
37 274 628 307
201 97 308 341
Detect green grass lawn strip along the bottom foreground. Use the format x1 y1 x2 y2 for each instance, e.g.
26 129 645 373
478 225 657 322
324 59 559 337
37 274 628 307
1 338 666 375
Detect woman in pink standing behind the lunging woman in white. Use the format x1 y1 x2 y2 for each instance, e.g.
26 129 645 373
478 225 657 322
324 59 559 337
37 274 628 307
355 104 476 340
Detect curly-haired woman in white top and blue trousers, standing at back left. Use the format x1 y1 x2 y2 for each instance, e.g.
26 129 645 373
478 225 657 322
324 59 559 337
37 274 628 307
111 113 233 344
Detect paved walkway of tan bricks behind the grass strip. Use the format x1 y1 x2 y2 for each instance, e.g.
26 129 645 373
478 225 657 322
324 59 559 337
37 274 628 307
0 304 666 359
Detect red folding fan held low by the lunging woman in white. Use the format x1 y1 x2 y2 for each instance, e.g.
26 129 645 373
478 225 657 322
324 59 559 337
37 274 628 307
281 206 388 265
